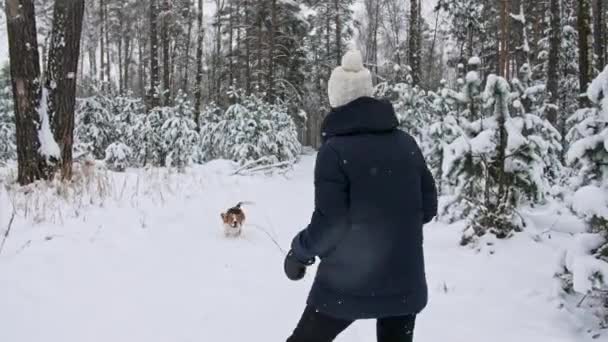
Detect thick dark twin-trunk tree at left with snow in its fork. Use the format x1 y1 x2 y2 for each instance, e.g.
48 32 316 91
6 0 84 185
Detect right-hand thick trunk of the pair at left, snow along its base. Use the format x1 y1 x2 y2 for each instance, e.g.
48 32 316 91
46 0 84 180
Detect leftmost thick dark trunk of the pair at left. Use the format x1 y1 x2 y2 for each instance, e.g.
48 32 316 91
5 0 46 185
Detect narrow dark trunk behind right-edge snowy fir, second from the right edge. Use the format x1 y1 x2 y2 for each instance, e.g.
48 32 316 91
577 0 593 107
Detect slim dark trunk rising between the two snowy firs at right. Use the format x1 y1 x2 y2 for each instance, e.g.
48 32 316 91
546 0 562 127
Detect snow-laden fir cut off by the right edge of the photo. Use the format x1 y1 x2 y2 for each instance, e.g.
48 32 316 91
558 66 608 328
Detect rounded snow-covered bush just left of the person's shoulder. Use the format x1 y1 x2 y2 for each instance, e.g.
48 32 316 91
201 92 302 165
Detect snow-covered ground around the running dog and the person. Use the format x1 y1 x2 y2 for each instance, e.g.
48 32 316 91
0 156 608 342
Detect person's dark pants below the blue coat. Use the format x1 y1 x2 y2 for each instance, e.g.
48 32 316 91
287 307 416 342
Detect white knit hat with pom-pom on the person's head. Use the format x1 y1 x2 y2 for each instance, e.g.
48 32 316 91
327 50 374 108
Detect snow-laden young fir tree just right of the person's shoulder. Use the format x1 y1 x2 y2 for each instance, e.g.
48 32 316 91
442 71 561 244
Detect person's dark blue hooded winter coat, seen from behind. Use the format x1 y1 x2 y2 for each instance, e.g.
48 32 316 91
292 98 437 320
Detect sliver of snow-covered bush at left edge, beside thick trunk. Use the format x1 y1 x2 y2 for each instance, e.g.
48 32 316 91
0 65 17 163
